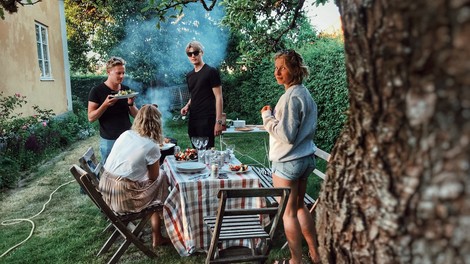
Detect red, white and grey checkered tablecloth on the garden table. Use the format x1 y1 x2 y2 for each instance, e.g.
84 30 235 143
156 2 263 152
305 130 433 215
163 156 265 256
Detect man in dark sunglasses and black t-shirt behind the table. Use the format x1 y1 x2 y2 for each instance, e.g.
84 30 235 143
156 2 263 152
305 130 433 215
181 41 224 149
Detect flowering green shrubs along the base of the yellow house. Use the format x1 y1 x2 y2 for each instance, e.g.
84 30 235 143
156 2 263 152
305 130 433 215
0 94 95 188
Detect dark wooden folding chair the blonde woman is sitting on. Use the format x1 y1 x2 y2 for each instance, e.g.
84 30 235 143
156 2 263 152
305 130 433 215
70 165 163 263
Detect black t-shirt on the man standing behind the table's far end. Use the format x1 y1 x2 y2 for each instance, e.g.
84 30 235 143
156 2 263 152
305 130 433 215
186 64 222 119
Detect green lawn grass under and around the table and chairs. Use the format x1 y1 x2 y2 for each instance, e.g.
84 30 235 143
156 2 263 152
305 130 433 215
0 120 319 264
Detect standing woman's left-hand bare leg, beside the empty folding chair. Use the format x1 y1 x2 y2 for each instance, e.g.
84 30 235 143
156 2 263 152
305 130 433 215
273 174 303 264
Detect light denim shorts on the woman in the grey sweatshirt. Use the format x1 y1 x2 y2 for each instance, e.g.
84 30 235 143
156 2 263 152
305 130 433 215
272 155 316 181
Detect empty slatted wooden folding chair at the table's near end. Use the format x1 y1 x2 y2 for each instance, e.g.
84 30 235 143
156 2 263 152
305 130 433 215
204 188 290 263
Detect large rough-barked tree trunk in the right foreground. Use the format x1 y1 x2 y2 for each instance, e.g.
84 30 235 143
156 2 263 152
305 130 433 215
316 0 470 263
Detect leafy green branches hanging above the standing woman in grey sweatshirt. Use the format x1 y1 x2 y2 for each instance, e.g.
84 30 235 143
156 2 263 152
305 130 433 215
222 0 312 67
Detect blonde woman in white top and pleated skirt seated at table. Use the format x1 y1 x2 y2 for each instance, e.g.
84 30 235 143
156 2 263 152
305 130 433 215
99 105 169 248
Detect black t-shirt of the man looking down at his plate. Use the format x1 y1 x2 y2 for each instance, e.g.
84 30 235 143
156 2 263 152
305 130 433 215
88 83 132 140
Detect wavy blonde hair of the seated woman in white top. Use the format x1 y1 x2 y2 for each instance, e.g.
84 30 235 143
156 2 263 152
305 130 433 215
132 105 163 144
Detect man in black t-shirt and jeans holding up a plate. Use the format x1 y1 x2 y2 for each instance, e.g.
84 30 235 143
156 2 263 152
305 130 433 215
88 57 138 164
